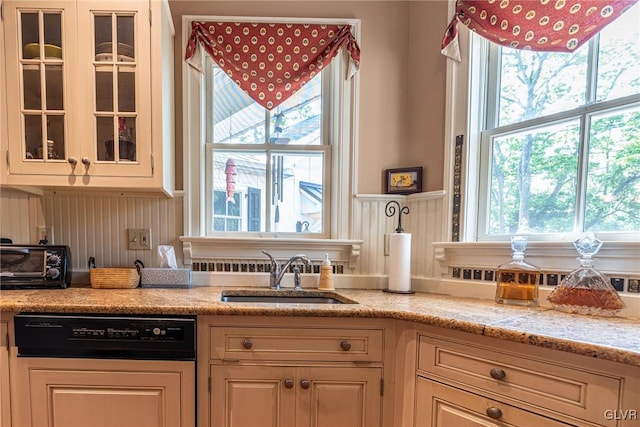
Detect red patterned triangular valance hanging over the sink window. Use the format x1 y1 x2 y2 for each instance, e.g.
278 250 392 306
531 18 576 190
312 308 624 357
185 22 360 110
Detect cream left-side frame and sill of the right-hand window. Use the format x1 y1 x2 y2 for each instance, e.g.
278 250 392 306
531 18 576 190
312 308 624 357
440 0 640 280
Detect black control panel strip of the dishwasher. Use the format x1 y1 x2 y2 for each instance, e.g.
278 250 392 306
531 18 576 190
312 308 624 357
14 313 196 360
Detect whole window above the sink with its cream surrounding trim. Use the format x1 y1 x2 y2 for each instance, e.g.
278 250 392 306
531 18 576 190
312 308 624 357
182 16 360 244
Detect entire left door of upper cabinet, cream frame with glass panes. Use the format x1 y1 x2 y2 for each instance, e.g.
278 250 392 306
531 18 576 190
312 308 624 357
3 0 78 176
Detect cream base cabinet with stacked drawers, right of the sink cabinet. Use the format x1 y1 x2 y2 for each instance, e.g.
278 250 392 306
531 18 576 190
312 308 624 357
403 327 640 427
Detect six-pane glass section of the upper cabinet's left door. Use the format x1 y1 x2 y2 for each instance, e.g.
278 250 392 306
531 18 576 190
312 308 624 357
18 9 68 163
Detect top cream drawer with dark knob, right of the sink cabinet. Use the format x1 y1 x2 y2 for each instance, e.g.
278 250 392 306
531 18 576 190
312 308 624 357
418 335 623 426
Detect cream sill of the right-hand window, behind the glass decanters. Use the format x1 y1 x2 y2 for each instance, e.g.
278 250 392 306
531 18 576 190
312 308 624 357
433 241 640 277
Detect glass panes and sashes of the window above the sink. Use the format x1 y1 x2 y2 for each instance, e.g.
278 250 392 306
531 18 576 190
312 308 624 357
204 56 331 235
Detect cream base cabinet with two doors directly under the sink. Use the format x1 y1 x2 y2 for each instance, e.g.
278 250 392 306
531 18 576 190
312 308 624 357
198 316 393 427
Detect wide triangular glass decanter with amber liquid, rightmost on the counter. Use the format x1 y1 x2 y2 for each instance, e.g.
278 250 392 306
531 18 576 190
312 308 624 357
547 233 624 317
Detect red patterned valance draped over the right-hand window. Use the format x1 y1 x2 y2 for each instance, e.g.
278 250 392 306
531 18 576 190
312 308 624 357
442 0 638 61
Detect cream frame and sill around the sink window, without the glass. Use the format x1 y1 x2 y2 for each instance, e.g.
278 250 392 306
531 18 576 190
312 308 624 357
180 15 362 256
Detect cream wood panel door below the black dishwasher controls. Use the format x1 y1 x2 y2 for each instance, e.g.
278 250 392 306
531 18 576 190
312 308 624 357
11 357 195 427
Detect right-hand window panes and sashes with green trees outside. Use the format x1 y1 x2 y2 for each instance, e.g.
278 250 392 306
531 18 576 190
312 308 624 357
468 6 640 240
